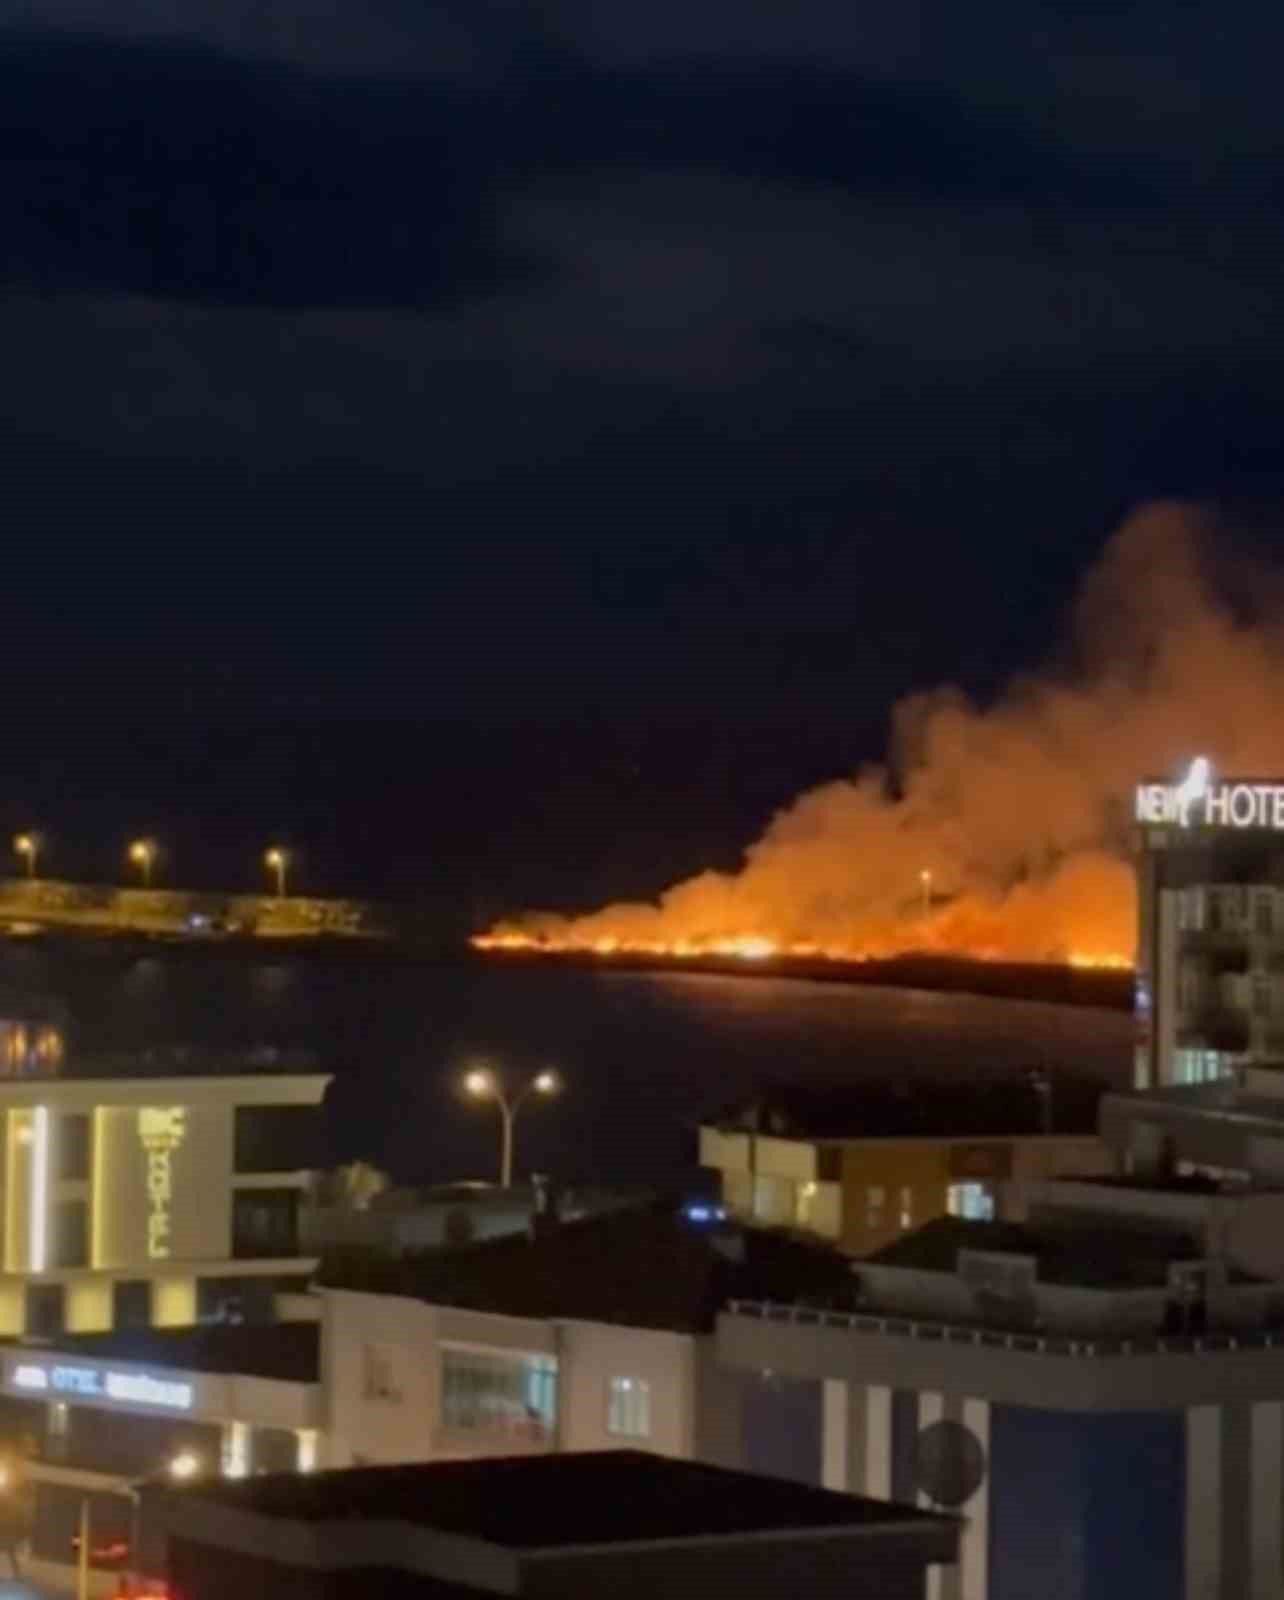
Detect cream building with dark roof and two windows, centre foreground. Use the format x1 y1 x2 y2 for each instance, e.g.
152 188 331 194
319 1206 852 1477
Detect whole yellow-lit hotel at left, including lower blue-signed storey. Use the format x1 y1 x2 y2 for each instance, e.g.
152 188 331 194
0 1034 330 1587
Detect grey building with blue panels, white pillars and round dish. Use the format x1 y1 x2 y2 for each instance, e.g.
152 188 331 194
717 1179 1284 1600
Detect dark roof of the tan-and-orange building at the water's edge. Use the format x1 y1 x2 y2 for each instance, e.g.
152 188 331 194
704 1072 1105 1139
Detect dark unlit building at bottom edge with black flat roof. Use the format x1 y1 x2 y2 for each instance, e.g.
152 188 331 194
157 1451 959 1600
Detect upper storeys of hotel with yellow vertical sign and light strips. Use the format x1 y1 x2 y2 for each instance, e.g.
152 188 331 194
0 1074 328 1338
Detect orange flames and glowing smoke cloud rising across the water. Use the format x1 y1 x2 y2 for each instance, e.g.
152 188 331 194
474 504 1284 968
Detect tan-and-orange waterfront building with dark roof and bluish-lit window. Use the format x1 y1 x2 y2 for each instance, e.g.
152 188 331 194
700 1080 1114 1256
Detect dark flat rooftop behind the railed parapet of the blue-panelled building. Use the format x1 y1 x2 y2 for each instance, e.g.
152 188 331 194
869 1216 1202 1290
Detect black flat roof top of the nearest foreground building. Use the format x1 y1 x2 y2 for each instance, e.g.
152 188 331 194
178 1450 953 1550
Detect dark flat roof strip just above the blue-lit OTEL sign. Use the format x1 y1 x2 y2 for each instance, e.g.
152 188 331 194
5 1322 320 1384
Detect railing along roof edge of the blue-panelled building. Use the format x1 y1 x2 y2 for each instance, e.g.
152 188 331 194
725 1299 1284 1357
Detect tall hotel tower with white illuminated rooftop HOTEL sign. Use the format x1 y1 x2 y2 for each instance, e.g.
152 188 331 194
1134 762 1284 1090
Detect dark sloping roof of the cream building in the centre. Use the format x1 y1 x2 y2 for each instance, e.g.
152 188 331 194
320 1205 857 1333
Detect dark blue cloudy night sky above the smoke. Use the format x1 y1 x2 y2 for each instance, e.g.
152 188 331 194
0 0 1284 920
